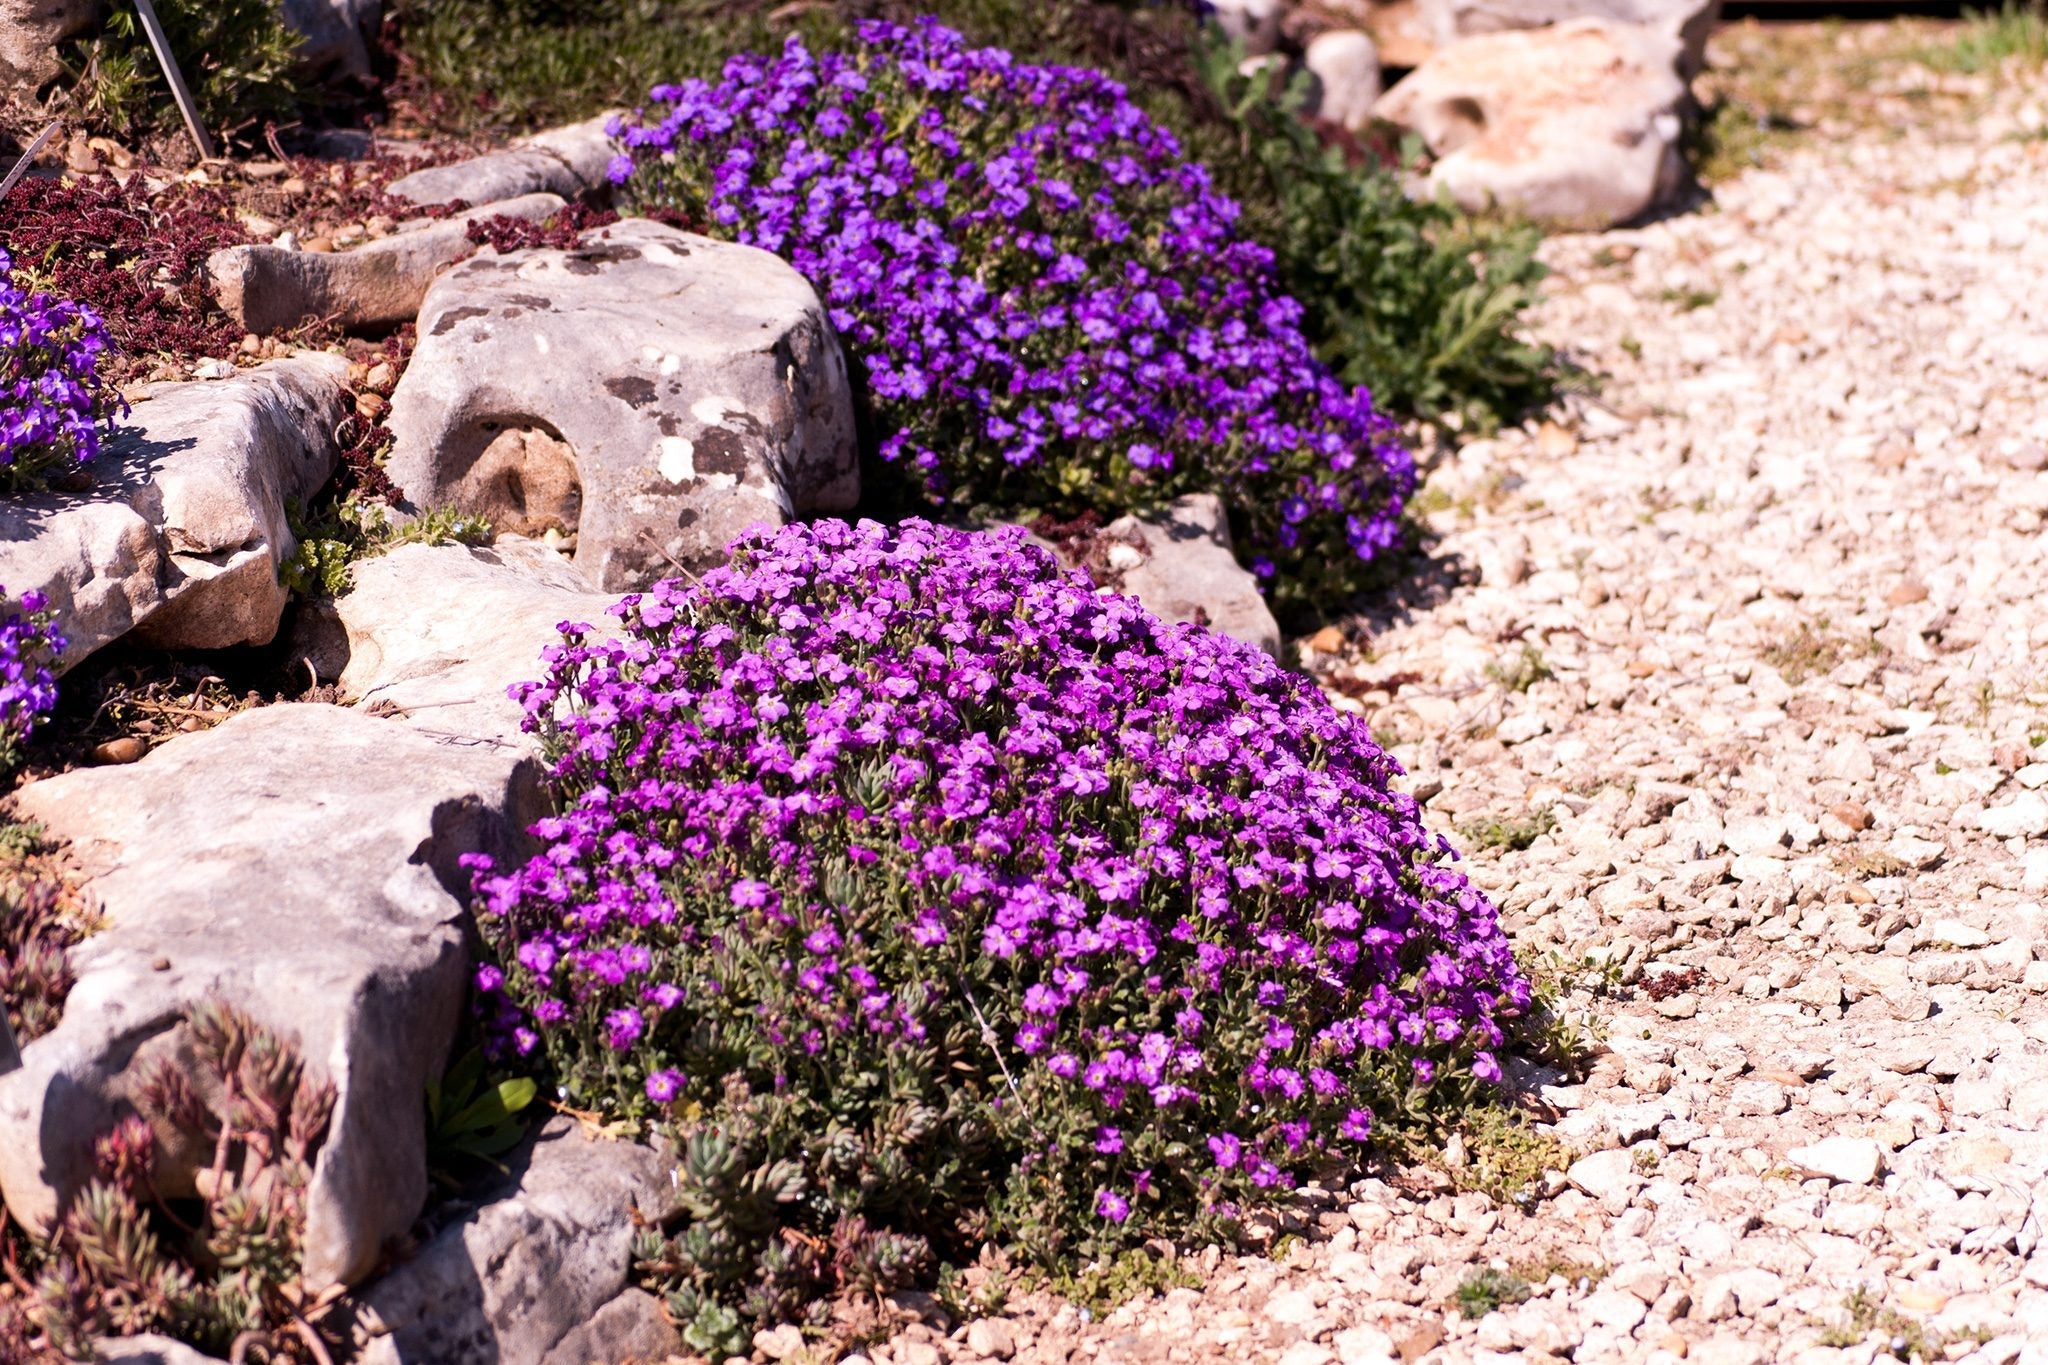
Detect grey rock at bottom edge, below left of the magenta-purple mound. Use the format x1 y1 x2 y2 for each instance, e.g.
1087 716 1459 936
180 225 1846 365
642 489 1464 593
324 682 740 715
356 1117 680 1365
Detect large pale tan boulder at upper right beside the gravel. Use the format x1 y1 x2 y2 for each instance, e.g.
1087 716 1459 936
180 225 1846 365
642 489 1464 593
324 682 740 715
1378 18 1692 229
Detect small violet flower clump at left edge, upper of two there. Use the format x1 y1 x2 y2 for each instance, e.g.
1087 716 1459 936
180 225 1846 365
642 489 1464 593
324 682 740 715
0 250 115 487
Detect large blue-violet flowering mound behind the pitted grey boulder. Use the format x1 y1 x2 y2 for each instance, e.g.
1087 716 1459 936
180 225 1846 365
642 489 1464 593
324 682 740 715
612 20 1415 602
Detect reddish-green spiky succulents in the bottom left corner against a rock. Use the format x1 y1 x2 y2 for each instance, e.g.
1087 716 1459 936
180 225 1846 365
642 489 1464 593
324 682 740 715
0 1003 334 1361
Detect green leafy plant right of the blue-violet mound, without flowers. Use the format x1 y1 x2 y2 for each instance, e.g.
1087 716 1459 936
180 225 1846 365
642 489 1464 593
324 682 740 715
1198 35 1567 430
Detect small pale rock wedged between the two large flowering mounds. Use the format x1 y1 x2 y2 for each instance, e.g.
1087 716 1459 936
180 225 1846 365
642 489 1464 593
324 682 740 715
1040 493 1280 659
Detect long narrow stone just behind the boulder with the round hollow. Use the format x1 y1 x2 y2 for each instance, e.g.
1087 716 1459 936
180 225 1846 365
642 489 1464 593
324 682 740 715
207 194 563 332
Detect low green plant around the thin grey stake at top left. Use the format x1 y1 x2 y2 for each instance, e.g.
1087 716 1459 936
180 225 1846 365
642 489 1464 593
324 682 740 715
68 0 299 141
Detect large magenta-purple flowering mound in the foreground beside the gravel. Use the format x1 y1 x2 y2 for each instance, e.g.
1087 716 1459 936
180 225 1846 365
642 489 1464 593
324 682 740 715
477 520 1530 1357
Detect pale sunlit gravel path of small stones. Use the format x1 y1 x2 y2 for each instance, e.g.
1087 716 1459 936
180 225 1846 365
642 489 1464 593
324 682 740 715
843 34 2048 1365
